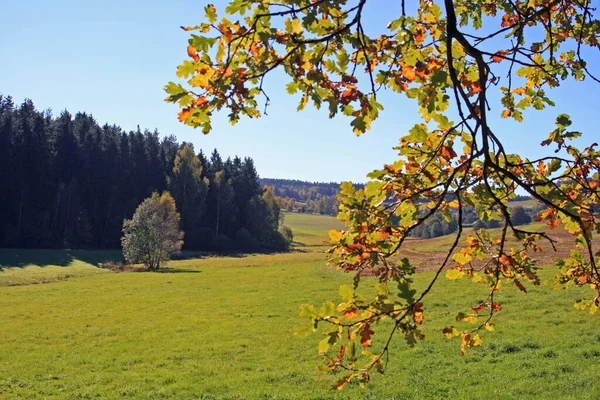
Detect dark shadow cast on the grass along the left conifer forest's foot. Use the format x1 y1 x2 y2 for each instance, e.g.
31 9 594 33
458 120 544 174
0 249 124 270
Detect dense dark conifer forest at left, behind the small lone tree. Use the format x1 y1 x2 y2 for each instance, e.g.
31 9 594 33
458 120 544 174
0 95 289 250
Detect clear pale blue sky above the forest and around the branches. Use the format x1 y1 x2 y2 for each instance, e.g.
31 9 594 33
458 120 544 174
0 0 600 182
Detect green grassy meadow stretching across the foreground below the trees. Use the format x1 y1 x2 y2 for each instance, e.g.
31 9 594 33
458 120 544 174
0 214 600 399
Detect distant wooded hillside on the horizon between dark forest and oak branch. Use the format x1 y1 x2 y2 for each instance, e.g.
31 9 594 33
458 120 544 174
260 178 363 215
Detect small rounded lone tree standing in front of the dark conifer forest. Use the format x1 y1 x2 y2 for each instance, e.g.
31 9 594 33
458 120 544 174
121 192 183 271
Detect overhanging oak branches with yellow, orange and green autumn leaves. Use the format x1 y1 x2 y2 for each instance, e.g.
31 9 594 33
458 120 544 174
166 0 600 389
